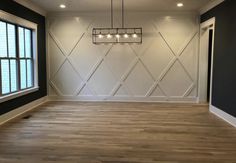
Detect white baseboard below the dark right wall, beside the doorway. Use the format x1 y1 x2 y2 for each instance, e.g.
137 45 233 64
210 105 236 127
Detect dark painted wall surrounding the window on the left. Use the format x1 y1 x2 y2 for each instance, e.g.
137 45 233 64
0 0 47 115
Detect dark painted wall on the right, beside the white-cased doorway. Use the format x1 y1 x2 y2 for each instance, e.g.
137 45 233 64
201 0 236 117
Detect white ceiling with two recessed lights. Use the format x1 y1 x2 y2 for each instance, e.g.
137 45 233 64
31 0 212 12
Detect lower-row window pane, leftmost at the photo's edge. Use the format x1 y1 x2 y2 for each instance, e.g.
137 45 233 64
1 60 10 94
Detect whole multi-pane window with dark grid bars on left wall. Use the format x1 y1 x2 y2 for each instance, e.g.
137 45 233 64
0 12 38 102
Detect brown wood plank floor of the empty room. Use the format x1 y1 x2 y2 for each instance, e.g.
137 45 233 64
0 102 236 163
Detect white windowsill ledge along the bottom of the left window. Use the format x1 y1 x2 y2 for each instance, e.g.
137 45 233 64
0 87 39 103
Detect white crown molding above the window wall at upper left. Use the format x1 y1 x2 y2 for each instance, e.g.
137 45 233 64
14 0 47 16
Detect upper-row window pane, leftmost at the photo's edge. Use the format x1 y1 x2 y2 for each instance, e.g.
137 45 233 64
0 21 7 57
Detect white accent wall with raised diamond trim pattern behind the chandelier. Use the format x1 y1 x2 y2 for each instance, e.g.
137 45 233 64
47 12 199 102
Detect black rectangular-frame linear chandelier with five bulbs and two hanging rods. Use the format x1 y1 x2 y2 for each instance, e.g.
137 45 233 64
92 0 142 44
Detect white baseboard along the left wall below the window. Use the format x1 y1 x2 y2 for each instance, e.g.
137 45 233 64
0 96 48 126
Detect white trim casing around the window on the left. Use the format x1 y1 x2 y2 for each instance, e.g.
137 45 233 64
0 10 39 103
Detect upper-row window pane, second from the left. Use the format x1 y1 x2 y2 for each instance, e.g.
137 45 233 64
7 24 16 57
